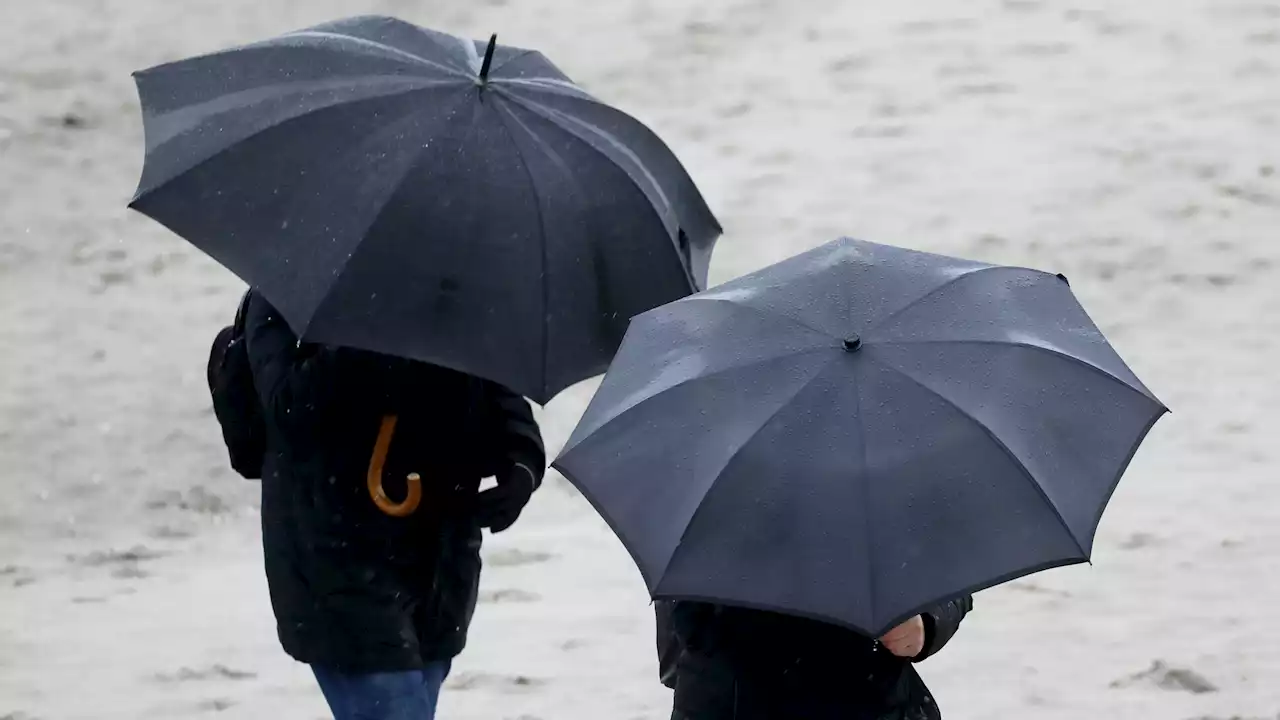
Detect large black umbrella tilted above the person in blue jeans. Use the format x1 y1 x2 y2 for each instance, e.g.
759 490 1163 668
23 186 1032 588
131 17 721 402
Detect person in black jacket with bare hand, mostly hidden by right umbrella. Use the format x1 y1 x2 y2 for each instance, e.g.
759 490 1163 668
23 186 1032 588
657 596 973 720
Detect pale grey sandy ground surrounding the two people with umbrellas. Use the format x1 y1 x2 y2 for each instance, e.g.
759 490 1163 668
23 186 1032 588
0 0 1280 720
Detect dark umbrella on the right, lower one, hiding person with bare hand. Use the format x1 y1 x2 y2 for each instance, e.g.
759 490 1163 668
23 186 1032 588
554 240 1166 637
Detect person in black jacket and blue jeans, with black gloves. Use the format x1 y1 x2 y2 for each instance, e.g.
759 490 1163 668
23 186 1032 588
244 292 545 720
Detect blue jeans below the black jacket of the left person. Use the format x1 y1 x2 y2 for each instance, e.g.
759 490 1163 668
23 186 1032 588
311 660 451 720
